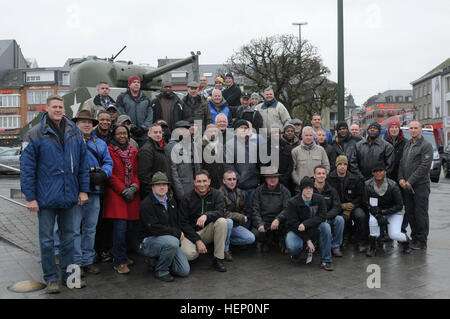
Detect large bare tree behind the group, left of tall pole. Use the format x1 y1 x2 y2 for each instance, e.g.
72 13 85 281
226 35 337 121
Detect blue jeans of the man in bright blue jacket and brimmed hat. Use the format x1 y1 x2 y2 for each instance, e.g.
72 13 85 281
74 194 100 266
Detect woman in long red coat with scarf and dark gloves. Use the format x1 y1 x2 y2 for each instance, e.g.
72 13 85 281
103 125 140 274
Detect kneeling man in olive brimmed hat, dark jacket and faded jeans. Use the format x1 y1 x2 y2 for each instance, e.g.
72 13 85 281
139 172 190 282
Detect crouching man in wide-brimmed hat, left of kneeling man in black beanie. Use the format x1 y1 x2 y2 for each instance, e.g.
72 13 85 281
252 166 291 252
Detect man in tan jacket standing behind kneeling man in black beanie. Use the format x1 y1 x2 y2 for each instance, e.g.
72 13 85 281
292 126 330 185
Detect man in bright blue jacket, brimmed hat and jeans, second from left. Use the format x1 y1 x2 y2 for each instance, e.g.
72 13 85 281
72 110 113 274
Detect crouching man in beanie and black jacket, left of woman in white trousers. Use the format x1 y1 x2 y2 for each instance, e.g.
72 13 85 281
327 155 369 253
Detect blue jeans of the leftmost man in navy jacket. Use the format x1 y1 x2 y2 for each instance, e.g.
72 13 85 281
38 206 76 283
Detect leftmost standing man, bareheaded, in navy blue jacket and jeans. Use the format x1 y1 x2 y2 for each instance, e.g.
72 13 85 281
20 95 89 293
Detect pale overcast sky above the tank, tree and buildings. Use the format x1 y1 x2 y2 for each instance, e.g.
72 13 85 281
0 0 450 105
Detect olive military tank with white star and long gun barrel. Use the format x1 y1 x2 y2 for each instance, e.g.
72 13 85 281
20 48 200 140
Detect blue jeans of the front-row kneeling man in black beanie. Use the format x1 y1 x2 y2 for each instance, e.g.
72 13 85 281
285 222 331 262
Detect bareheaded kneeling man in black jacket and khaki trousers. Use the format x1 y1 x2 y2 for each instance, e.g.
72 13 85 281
180 170 228 272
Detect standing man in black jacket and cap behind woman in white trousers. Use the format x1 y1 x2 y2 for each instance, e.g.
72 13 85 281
350 122 394 181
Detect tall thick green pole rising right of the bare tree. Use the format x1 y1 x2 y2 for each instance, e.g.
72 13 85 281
338 0 345 122
